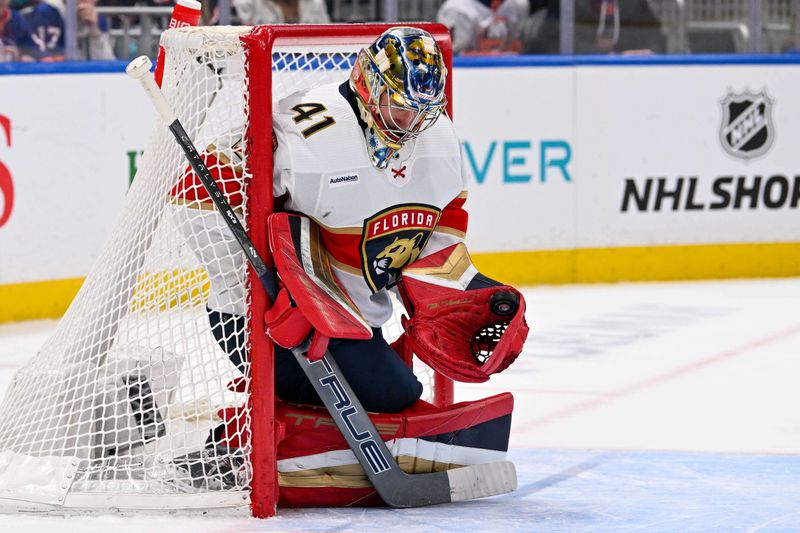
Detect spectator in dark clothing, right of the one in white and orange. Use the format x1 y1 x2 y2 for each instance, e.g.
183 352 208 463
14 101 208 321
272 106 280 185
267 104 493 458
524 0 666 54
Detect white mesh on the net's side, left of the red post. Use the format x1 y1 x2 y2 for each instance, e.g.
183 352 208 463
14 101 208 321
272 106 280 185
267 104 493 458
0 28 250 504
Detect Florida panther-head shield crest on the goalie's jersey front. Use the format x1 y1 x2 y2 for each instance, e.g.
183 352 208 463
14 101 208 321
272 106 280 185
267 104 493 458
361 205 441 292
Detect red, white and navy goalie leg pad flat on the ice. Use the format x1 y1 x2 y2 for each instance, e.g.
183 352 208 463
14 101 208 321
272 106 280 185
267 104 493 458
276 393 513 507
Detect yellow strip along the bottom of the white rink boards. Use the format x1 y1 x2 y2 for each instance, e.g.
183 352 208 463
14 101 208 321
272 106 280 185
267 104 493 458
0 242 800 323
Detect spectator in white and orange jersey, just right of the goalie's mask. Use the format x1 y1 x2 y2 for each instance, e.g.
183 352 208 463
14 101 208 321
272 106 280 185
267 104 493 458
436 0 530 54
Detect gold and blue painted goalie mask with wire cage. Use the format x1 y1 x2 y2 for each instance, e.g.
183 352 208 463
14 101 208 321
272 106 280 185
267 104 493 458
350 27 447 168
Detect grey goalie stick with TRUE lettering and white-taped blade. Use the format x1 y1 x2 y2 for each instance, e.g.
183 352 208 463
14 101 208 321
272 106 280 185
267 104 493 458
126 56 517 508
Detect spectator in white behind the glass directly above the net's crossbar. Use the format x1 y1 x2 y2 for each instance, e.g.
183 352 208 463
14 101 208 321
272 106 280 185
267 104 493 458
231 0 331 25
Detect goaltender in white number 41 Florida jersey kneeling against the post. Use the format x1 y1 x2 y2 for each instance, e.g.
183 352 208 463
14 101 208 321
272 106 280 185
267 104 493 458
167 27 528 506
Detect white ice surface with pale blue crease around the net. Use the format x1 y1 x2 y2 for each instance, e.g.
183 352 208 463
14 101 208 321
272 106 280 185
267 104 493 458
0 278 800 533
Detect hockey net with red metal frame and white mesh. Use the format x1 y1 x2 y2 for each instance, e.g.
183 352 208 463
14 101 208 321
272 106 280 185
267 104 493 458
0 25 452 516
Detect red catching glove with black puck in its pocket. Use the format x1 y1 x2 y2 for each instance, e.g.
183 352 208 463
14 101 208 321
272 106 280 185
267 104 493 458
398 244 528 382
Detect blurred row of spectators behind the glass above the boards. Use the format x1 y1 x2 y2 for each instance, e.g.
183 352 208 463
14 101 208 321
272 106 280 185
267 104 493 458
0 0 796 62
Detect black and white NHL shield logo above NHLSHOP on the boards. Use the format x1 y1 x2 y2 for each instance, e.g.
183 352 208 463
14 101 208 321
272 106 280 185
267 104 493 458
719 90 775 160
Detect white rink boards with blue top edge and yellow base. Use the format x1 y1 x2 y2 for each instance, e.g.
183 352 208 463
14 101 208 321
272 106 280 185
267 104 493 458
0 56 800 321
